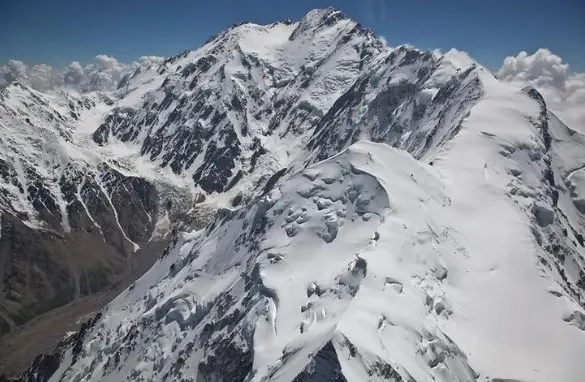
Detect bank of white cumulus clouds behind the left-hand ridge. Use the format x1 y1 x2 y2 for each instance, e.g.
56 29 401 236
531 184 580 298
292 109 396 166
0 54 164 92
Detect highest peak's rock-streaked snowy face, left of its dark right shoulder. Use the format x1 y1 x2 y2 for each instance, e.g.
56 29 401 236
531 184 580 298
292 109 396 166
94 10 383 197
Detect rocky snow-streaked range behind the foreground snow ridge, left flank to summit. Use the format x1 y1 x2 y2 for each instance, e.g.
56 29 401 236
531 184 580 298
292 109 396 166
0 5 481 336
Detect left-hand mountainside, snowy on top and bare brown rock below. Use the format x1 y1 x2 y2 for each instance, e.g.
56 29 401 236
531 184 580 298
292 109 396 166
0 65 202 358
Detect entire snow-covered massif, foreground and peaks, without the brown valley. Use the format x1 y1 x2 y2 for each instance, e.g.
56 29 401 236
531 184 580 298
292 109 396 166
0 9 585 382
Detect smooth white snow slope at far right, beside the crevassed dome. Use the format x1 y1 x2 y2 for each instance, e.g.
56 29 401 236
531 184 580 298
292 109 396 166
424 72 585 381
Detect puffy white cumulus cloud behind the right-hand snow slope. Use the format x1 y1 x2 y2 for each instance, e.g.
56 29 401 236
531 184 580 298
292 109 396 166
497 49 585 132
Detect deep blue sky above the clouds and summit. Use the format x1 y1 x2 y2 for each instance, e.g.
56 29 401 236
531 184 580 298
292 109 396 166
0 0 585 71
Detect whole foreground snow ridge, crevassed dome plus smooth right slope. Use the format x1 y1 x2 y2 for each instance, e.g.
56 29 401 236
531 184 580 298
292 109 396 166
52 75 585 382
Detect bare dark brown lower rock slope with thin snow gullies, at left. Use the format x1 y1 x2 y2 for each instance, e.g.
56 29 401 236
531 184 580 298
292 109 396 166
0 163 164 326
